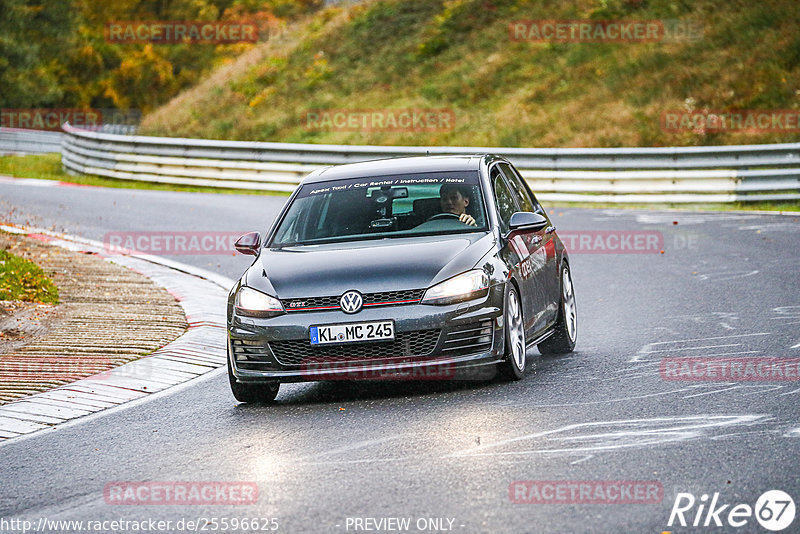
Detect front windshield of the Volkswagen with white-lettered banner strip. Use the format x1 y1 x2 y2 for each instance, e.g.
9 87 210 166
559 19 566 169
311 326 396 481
270 171 488 248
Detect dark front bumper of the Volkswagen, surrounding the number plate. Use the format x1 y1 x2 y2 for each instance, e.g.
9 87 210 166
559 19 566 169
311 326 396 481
228 285 504 383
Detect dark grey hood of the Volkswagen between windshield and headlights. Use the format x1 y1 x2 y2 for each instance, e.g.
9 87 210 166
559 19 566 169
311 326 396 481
245 233 494 299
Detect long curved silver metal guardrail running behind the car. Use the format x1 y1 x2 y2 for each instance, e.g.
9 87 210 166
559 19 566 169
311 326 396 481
62 124 800 203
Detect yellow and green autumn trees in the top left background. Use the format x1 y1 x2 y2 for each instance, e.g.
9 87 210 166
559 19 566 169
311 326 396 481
0 0 322 113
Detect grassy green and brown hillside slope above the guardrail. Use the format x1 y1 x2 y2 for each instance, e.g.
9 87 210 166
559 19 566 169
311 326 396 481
142 0 800 147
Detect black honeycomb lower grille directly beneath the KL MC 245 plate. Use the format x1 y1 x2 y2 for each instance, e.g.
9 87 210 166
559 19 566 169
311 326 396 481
269 329 441 365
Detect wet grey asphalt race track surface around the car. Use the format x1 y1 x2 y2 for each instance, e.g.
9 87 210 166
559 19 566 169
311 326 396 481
0 184 800 533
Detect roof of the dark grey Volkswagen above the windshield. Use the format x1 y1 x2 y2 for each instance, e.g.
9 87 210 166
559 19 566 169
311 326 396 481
301 155 491 184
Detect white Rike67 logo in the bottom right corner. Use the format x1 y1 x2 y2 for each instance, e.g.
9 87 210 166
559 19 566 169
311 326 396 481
667 490 795 532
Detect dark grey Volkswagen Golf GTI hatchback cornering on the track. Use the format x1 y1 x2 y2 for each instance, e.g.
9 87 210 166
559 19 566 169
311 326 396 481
228 155 577 402
